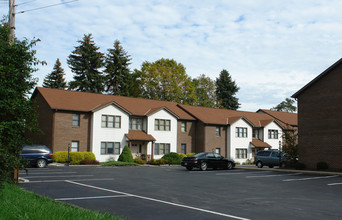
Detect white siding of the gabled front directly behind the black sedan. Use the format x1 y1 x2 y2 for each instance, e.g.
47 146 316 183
227 119 253 163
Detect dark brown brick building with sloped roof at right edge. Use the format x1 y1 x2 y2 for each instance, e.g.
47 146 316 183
292 59 342 170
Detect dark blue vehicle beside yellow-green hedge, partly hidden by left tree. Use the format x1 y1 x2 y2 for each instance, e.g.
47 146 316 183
20 145 53 168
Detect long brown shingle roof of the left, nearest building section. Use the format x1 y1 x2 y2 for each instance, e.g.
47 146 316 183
33 87 194 120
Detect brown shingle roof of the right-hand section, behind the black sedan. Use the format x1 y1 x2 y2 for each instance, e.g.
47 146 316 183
179 105 283 127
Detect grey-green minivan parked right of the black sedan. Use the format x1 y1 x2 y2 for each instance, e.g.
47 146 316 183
254 150 284 168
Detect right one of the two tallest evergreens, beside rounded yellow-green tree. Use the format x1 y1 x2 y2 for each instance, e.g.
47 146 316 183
104 40 132 96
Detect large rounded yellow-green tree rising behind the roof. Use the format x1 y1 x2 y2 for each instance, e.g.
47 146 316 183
140 58 196 104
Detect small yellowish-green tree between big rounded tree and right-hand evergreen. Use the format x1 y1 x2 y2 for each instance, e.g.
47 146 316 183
192 74 217 108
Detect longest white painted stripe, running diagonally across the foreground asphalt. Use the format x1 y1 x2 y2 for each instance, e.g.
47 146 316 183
66 180 248 220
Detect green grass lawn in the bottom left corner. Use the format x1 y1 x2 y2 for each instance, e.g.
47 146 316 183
0 184 125 220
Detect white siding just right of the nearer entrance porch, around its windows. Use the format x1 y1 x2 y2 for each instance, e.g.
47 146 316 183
147 109 177 159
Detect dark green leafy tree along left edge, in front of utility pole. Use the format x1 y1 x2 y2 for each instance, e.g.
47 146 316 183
0 23 42 183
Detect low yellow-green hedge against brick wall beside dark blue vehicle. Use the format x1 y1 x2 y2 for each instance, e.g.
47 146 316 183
52 151 96 164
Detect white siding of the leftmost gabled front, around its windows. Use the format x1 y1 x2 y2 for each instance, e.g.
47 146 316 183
91 105 129 162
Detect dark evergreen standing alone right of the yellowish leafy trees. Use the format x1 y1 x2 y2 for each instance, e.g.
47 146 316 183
216 69 240 110
